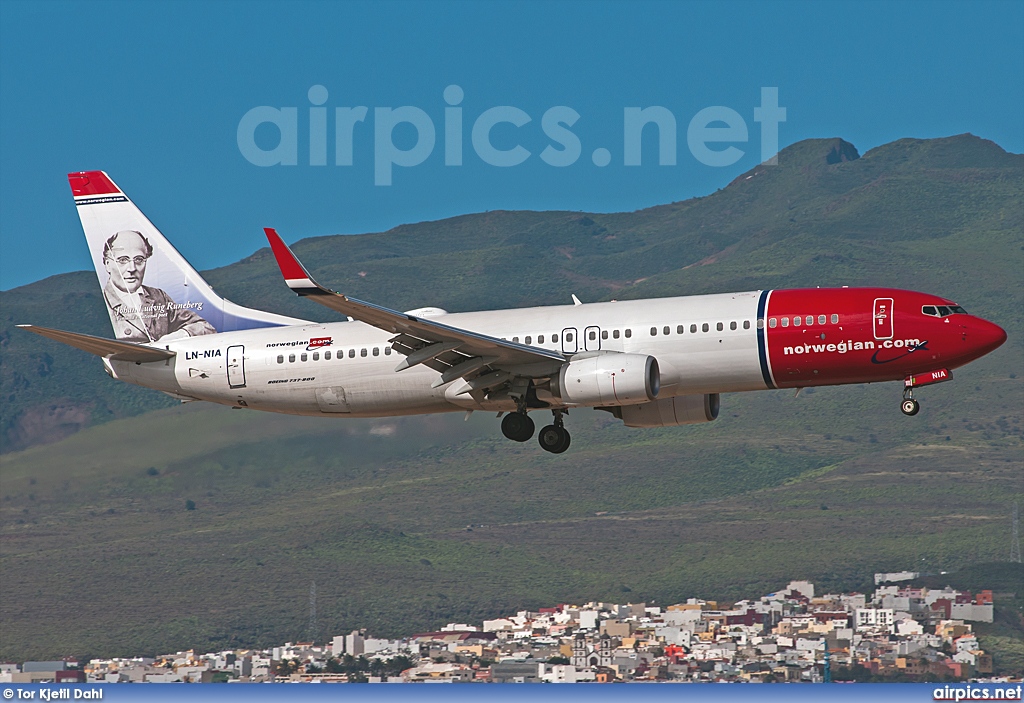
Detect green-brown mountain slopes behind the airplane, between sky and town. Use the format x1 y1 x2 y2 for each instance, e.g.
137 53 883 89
0 135 1024 670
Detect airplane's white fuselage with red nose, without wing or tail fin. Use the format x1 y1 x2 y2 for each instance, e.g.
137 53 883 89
105 288 1006 416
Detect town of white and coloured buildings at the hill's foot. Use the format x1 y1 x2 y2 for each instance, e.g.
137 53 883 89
6 573 1008 684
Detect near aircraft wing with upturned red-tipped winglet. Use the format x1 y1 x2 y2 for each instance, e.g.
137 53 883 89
263 227 565 392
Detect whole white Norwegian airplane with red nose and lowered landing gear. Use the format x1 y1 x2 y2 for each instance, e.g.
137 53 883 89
19 171 1007 453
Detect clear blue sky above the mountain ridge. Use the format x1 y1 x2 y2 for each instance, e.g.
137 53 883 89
0 0 1024 290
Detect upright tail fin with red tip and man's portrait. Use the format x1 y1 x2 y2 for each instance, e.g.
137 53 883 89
68 171 307 343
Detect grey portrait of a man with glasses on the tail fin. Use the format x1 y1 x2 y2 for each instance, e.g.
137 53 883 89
102 229 217 343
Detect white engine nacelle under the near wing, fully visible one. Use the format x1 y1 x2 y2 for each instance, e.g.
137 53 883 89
552 354 662 405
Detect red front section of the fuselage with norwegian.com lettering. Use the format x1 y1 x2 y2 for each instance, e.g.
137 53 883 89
765 288 1006 388
